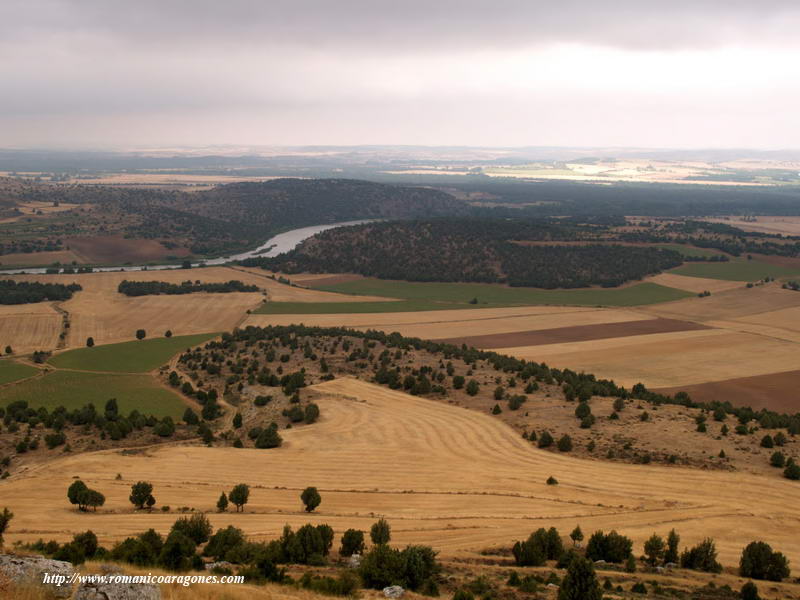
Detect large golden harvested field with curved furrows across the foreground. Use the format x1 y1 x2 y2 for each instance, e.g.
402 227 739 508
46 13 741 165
6 379 800 566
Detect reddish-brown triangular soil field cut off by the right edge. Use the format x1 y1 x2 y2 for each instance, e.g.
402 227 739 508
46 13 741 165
655 371 800 414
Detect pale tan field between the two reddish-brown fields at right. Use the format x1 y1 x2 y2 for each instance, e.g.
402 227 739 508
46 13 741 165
497 329 800 388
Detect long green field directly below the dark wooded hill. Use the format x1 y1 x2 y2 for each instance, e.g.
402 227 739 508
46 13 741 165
310 278 693 312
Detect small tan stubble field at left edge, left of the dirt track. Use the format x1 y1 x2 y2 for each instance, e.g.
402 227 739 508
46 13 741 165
0 302 61 354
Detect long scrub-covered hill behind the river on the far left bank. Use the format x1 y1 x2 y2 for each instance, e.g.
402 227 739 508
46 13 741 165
0 179 469 255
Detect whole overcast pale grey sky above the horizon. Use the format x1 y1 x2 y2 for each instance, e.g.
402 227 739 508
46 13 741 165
0 0 800 148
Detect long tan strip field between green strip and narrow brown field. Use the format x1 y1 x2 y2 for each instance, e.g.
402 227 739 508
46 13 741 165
239 306 652 339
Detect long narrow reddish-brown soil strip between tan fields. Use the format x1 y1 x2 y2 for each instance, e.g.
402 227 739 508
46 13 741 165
438 319 710 348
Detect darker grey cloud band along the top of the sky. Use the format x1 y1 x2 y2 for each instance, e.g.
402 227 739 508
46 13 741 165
0 0 800 53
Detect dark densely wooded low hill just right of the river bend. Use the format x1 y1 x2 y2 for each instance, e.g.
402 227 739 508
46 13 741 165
244 219 682 289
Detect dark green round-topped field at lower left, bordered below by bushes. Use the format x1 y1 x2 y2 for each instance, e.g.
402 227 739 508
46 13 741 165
0 371 185 418
